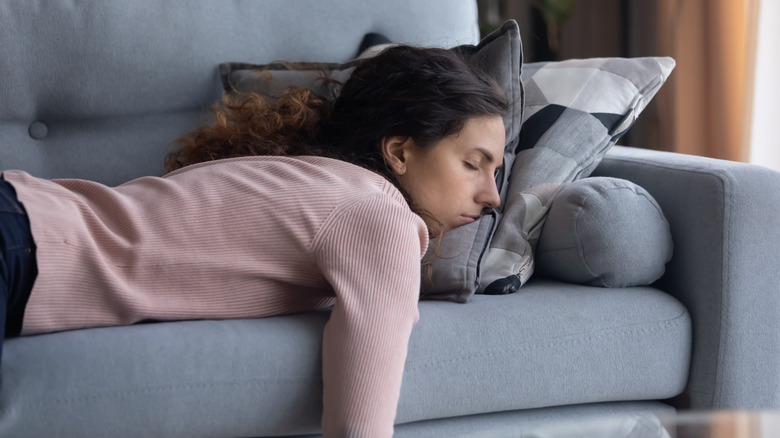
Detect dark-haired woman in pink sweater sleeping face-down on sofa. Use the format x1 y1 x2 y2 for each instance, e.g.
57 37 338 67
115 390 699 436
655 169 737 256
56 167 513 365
0 46 506 437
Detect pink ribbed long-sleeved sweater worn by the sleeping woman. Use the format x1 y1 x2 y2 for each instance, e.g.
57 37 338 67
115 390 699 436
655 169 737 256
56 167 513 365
3 157 428 437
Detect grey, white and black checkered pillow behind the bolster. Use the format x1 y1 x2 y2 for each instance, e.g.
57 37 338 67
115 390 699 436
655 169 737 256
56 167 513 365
478 57 675 294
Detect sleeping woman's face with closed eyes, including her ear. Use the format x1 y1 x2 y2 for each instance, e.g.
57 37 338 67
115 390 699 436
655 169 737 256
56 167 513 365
396 115 505 231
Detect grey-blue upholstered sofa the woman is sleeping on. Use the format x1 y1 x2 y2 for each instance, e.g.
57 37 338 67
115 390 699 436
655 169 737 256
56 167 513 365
0 0 780 437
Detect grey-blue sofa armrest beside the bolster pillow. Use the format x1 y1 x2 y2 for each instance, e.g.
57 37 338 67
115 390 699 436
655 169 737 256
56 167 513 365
594 146 780 410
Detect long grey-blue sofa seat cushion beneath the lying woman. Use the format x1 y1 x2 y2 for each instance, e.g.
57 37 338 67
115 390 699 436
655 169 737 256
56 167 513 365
0 279 691 437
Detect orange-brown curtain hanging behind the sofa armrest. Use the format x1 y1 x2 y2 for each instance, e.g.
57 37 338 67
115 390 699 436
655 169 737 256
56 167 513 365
658 0 759 161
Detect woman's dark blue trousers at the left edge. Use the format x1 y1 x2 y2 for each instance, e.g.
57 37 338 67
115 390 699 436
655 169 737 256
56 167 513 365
0 178 38 363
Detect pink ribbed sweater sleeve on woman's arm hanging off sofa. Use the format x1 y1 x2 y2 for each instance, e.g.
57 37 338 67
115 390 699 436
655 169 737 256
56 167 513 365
313 194 428 437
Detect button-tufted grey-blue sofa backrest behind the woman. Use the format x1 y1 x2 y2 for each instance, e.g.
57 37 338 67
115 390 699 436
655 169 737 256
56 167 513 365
0 0 479 185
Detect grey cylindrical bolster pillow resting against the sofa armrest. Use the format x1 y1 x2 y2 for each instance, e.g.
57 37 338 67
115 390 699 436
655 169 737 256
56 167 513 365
536 177 672 287
